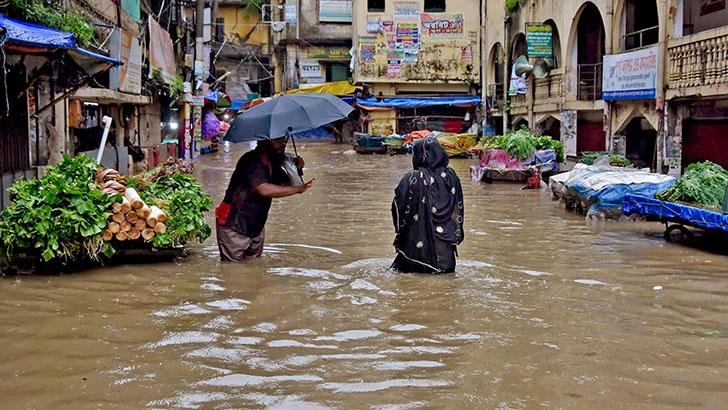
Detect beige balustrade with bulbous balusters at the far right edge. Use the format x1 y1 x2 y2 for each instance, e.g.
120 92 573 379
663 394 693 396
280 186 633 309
667 26 728 89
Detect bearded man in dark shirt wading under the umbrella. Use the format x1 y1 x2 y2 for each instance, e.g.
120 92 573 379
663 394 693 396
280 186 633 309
215 137 316 262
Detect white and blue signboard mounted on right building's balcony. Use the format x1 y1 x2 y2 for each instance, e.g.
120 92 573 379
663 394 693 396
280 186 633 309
602 46 659 100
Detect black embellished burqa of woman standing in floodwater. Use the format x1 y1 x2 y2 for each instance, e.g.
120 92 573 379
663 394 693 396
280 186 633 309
392 138 464 273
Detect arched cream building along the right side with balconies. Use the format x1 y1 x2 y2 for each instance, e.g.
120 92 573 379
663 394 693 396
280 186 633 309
483 0 728 174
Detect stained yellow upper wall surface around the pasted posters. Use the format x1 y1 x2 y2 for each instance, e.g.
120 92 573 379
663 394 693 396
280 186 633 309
352 0 480 84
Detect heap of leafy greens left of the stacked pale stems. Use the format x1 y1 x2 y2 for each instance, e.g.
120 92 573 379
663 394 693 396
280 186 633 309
0 155 121 261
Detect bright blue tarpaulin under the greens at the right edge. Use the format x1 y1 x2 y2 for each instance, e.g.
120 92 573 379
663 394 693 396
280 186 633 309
622 195 728 232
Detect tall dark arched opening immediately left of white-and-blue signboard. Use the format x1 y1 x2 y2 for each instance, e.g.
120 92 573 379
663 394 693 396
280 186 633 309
572 3 605 101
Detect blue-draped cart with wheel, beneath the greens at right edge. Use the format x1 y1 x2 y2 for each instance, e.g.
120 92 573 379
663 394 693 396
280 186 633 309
622 195 728 242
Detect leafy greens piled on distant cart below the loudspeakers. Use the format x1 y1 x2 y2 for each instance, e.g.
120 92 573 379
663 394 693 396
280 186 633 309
478 126 566 163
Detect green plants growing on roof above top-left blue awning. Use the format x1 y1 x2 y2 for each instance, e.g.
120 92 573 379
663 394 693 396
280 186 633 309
9 0 94 46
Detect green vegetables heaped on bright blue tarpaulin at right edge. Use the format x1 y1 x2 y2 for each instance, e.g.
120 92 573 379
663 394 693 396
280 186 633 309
655 161 728 208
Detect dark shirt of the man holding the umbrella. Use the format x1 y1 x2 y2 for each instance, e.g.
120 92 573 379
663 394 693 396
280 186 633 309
224 150 288 238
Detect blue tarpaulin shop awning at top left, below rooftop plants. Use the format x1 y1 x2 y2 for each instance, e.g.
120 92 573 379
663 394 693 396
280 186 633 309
0 14 122 65
